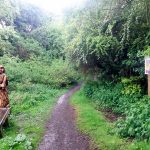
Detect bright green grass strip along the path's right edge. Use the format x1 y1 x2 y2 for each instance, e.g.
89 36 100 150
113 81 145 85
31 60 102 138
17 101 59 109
71 91 150 150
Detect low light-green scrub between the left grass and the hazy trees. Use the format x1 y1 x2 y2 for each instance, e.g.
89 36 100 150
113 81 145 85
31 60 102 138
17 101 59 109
0 55 79 89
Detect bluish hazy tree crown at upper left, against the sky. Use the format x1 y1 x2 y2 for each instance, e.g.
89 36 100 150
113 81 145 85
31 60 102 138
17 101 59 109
14 3 51 33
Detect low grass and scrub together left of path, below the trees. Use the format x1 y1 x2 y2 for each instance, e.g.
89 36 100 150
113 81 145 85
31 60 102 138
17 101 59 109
0 55 79 150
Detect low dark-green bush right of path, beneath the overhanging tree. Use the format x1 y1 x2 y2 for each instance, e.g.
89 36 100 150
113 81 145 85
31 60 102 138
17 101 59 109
83 81 139 114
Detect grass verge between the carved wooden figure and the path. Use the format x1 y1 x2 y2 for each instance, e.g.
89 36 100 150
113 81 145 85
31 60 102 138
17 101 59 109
0 83 65 150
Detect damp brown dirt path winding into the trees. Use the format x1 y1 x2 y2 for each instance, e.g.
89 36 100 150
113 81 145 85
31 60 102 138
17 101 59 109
38 86 89 150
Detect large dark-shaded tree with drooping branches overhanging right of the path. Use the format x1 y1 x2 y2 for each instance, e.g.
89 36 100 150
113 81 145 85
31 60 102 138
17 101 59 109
63 0 150 79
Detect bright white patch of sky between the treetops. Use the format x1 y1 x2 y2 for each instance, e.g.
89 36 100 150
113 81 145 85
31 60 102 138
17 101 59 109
22 0 85 15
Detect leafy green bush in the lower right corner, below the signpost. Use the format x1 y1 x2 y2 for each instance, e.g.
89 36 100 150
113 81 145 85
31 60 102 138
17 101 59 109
116 97 150 140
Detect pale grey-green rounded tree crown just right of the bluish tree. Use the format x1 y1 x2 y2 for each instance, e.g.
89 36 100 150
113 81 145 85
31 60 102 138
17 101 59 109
32 24 64 58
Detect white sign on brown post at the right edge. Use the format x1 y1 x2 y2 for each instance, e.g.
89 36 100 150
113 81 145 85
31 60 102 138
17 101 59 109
145 57 150 96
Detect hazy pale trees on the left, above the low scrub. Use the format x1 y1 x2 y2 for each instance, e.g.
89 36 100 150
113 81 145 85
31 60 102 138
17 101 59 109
0 0 64 60
